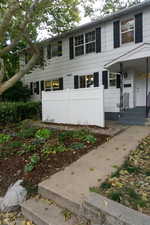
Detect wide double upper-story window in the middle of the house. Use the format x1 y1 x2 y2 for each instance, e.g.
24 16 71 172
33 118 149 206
74 31 96 56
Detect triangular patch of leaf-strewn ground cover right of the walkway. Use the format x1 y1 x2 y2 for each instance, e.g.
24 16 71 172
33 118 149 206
91 136 150 215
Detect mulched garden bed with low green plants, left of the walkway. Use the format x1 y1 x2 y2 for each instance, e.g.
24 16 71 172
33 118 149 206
0 120 108 195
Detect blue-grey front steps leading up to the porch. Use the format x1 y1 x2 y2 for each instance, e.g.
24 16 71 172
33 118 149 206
119 107 147 126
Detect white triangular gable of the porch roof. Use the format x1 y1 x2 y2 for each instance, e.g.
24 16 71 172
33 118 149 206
104 43 150 69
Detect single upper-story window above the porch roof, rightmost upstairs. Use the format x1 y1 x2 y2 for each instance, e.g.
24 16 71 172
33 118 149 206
121 18 135 44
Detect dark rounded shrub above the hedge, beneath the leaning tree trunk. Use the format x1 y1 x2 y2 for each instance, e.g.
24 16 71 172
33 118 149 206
2 81 31 102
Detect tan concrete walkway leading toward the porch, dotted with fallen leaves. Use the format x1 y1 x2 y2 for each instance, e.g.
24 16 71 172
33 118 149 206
39 126 150 213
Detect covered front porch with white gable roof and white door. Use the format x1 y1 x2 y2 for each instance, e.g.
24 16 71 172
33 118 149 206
105 43 150 120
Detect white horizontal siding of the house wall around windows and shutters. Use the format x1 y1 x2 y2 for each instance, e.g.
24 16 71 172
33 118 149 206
22 8 150 112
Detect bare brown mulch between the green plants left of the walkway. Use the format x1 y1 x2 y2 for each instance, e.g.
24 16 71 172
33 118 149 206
0 124 109 196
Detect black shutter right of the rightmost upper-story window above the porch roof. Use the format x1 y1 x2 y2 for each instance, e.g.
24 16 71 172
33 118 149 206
135 13 143 43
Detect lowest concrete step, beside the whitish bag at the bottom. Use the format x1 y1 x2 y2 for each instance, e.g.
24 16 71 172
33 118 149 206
22 199 86 225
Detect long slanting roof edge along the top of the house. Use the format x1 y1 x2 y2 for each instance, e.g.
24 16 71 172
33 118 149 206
42 0 150 42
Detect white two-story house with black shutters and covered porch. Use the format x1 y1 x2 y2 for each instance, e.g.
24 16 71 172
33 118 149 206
21 0 150 124
